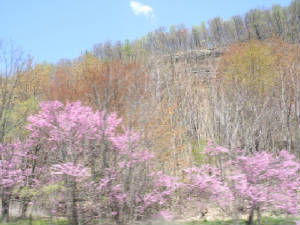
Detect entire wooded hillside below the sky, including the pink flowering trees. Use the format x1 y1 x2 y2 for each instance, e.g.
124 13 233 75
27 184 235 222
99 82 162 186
0 0 300 225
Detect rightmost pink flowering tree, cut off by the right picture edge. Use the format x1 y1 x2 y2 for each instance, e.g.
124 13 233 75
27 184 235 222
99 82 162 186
227 150 300 224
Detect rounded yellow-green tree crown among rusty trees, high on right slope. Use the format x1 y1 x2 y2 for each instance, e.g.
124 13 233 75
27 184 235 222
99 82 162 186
221 41 278 94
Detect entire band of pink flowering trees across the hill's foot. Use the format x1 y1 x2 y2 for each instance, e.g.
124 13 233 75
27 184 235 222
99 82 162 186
0 101 300 224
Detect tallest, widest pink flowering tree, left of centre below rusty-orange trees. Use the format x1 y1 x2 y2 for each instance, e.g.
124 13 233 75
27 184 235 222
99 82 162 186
27 101 176 225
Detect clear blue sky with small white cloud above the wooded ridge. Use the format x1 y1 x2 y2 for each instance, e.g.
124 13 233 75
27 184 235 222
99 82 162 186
0 0 291 63
